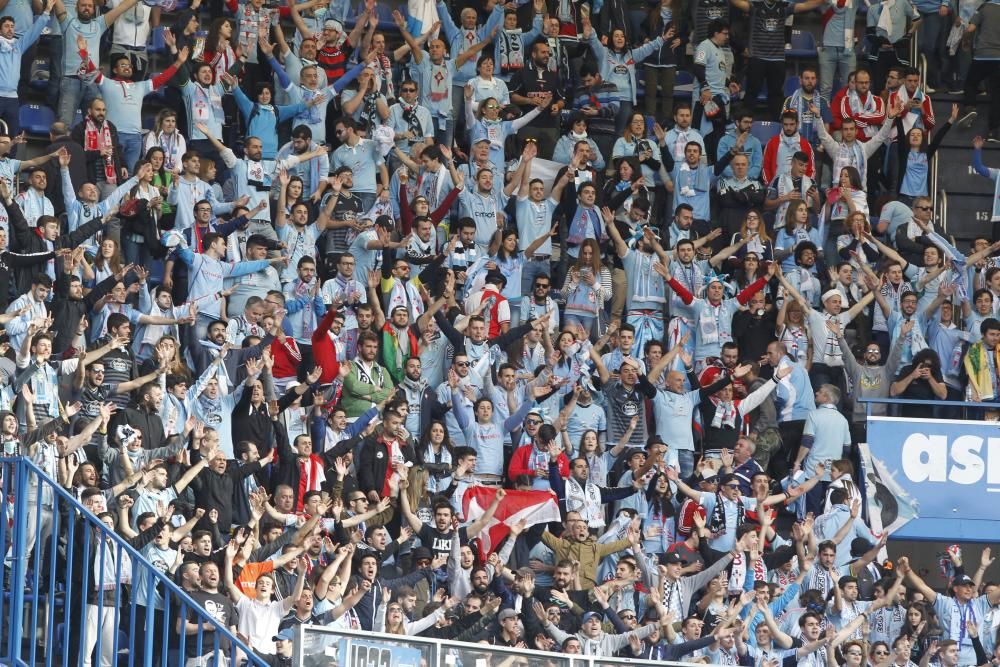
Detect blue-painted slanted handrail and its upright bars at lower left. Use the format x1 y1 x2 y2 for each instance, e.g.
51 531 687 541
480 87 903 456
0 457 267 667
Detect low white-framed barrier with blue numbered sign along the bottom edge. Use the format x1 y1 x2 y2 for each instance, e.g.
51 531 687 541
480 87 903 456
292 625 712 667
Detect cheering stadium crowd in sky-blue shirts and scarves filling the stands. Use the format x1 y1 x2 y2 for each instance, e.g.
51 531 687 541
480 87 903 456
0 0 1000 667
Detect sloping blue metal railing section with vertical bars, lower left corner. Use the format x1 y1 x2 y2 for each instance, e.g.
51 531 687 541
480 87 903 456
0 458 267 667
